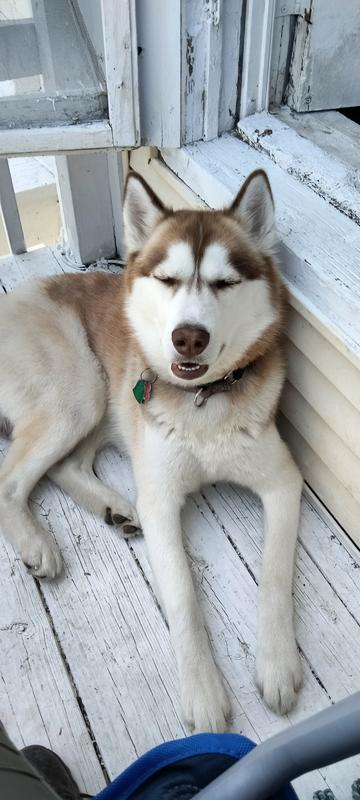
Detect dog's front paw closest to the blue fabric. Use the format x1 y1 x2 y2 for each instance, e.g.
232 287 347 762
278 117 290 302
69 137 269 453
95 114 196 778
182 659 231 733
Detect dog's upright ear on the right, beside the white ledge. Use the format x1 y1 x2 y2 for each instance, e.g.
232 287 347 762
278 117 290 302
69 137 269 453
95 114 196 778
229 169 277 253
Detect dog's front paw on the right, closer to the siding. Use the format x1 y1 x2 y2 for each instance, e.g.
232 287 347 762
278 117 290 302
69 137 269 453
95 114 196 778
256 640 302 714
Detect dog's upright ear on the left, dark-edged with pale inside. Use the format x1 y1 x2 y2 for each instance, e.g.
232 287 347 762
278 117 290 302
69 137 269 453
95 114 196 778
124 172 166 253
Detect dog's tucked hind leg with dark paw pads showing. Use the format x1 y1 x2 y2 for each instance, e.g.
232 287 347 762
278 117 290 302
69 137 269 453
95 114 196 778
48 427 140 536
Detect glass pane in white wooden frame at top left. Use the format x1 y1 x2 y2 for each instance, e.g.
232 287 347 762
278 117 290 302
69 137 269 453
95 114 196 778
0 0 107 129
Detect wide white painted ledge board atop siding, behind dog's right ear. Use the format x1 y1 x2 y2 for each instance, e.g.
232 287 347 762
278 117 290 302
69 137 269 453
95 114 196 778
162 134 360 363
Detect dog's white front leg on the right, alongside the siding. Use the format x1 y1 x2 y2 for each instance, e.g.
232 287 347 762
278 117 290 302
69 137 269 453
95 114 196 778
252 426 302 714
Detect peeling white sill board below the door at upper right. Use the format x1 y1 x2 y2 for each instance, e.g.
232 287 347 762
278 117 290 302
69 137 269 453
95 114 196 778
238 112 360 223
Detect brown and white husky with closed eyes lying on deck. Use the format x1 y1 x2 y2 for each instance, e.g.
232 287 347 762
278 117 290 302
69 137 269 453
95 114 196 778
0 170 302 731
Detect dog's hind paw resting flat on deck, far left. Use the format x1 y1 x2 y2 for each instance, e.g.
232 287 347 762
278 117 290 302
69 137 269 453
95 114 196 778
20 531 62 578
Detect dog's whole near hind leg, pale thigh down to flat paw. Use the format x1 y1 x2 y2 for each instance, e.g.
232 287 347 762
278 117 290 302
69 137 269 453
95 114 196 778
0 294 111 577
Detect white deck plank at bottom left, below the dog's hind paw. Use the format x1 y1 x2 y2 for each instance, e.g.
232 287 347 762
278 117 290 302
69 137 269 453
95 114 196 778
0 456 105 794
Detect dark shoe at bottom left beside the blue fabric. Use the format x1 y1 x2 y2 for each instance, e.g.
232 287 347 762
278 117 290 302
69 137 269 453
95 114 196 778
21 744 89 800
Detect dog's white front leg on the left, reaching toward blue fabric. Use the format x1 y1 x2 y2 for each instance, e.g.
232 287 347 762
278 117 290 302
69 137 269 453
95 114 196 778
134 432 229 731
